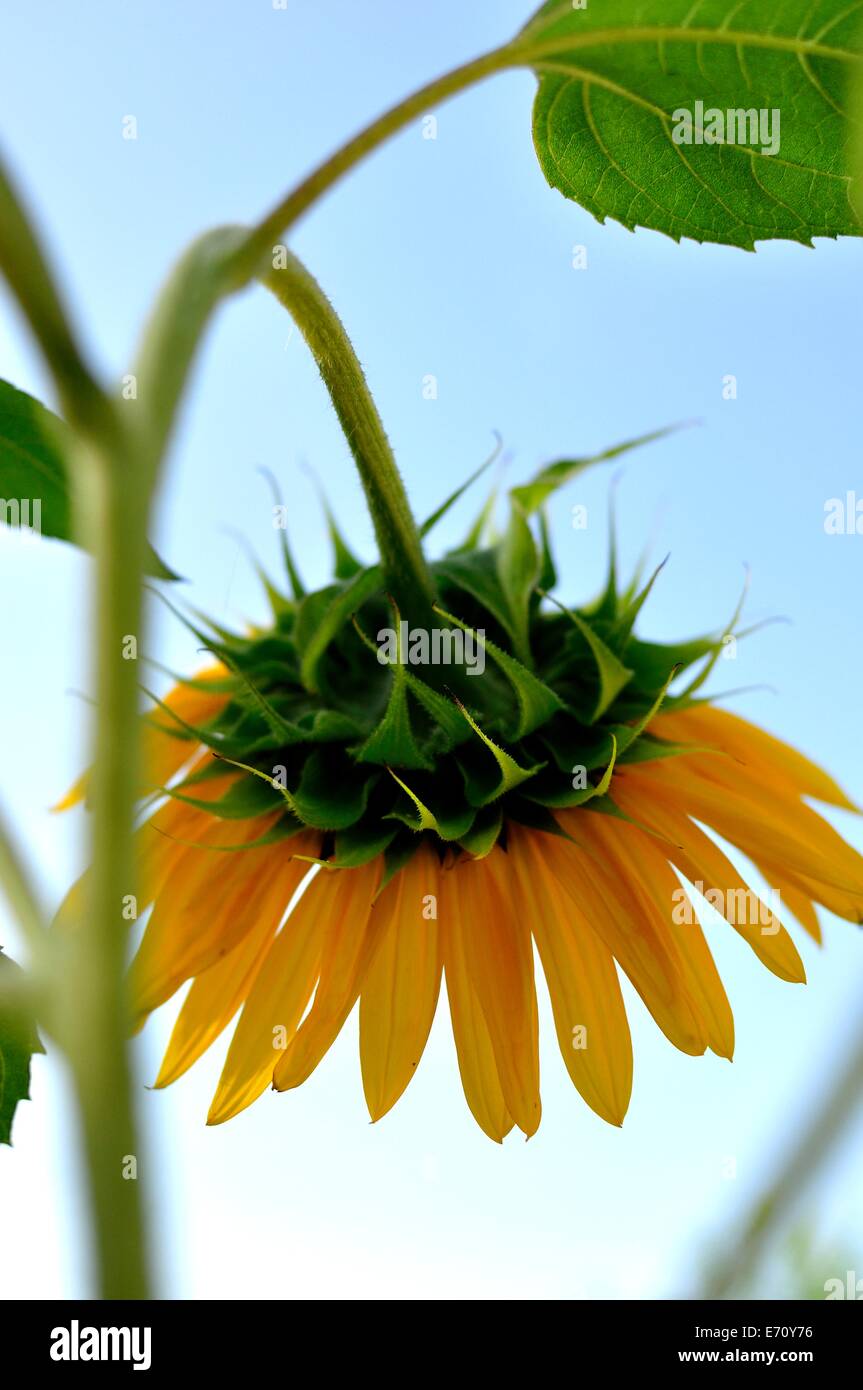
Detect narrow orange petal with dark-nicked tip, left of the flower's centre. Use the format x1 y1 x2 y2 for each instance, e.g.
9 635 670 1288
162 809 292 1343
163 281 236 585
272 859 380 1091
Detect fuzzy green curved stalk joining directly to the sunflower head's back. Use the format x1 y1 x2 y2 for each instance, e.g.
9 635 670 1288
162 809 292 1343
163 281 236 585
261 247 435 612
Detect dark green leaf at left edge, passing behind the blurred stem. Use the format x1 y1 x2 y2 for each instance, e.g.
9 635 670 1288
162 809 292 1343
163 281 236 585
0 381 179 580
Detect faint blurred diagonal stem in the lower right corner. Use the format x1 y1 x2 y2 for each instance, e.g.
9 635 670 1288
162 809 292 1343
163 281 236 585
700 1006 863 1298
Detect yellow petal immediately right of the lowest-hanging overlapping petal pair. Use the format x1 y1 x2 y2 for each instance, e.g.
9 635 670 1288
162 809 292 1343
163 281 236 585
507 827 632 1125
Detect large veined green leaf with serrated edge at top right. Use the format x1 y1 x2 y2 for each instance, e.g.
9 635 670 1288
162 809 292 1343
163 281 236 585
516 0 862 250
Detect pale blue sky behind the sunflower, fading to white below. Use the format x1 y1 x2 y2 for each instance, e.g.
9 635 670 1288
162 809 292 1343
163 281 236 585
0 0 863 1298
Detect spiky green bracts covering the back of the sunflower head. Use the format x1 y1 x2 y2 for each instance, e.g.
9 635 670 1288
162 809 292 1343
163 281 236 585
156 436 738 872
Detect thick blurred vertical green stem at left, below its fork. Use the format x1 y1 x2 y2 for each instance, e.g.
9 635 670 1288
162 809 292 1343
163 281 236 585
61 441 149 1298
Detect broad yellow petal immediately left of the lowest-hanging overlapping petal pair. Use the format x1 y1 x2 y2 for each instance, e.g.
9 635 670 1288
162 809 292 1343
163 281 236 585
360 845 442 1120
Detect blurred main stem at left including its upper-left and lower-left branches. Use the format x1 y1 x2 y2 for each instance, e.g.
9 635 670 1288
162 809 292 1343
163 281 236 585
0 157 150 1298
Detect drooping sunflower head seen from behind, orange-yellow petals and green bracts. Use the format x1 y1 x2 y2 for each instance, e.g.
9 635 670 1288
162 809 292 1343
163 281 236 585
63 455 863 1141
